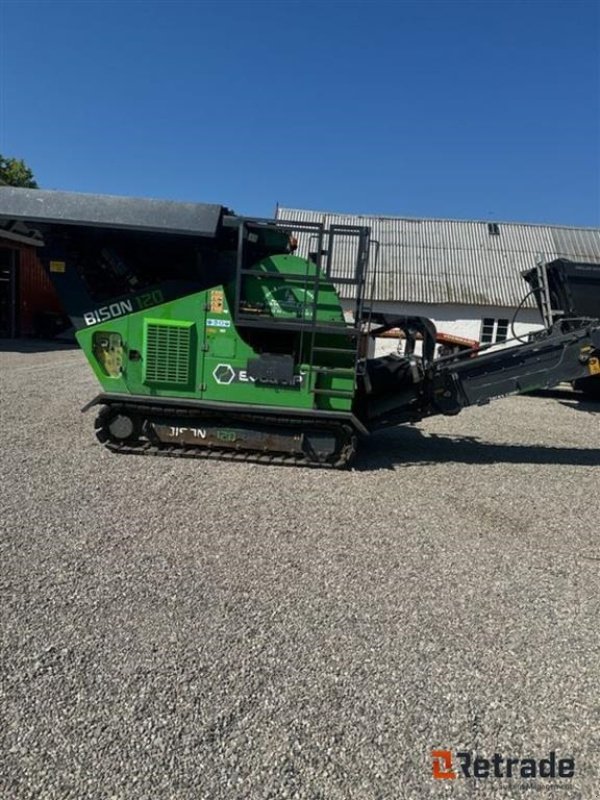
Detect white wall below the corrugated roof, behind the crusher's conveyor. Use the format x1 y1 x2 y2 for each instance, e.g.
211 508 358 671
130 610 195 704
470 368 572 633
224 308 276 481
343 301 543 356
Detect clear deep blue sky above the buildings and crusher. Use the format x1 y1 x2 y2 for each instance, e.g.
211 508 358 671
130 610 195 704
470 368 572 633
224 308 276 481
0 0 600 225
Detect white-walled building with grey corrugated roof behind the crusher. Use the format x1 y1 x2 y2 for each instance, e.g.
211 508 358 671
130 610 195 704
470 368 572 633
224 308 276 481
276 207 600 353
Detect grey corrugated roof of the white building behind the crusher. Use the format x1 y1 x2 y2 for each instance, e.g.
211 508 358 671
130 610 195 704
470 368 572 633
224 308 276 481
277 208 600 307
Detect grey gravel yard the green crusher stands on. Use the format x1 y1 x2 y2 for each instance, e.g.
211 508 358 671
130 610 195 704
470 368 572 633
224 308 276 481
0 343 600 800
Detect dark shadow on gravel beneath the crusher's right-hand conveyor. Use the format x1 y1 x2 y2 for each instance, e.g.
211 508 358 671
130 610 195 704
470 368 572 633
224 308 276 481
353 428 600 472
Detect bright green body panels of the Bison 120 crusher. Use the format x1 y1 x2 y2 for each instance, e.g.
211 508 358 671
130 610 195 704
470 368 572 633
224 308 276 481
77 256 355 411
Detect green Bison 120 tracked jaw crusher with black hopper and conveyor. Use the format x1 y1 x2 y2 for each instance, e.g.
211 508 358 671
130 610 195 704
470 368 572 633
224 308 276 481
0 187 600 467
